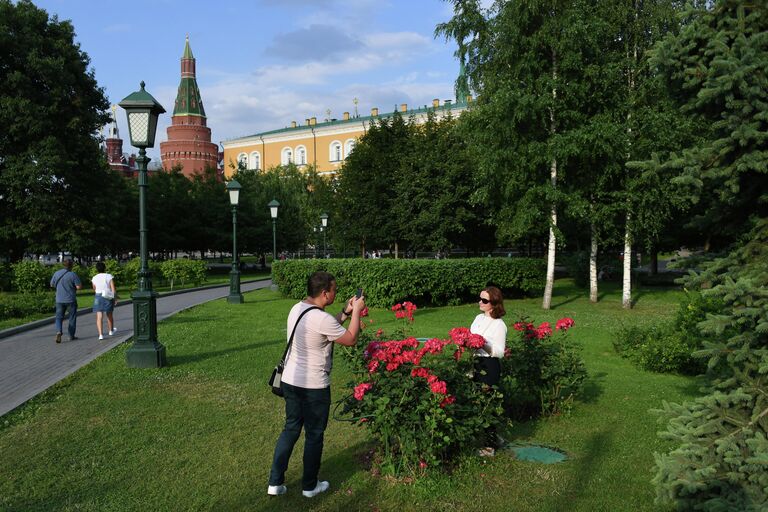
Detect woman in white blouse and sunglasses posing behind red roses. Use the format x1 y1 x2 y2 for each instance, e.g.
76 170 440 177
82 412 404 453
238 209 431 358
469 286 507 386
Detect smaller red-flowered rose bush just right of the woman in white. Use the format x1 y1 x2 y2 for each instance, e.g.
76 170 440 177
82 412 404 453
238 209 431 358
501 318 587 419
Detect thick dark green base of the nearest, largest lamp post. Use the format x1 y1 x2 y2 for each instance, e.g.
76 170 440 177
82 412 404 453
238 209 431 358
125 290 168 368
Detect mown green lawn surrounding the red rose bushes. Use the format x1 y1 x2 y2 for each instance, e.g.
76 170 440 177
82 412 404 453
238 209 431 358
0 280 697 511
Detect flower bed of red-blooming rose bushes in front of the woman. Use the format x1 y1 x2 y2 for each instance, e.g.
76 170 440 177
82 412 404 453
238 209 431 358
343 302 583 475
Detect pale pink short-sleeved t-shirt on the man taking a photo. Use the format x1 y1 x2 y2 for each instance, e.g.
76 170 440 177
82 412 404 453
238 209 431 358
282 302 347 389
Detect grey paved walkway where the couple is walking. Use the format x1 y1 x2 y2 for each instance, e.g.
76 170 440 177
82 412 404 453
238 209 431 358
0 279 271 416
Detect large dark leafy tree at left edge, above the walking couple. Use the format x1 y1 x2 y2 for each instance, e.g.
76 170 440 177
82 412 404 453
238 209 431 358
0 0 111 259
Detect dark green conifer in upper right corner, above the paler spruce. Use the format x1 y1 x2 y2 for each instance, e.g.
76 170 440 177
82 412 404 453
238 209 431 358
653 0 768 248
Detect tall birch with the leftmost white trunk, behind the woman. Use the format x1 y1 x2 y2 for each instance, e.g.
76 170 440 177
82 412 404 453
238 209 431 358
437 0 616 309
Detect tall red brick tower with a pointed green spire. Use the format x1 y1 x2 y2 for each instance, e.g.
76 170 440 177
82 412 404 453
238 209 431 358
160 36 219 177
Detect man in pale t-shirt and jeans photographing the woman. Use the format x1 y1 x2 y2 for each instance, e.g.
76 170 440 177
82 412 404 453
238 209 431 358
267 272 365 498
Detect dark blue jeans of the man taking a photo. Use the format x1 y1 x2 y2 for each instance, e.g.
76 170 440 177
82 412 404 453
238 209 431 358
269 383 331 491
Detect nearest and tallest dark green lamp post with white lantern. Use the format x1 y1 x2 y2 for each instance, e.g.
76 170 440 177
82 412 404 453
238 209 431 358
119 81 167 368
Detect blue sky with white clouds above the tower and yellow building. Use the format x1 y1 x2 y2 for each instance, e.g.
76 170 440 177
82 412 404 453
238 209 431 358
33 0 468 158
